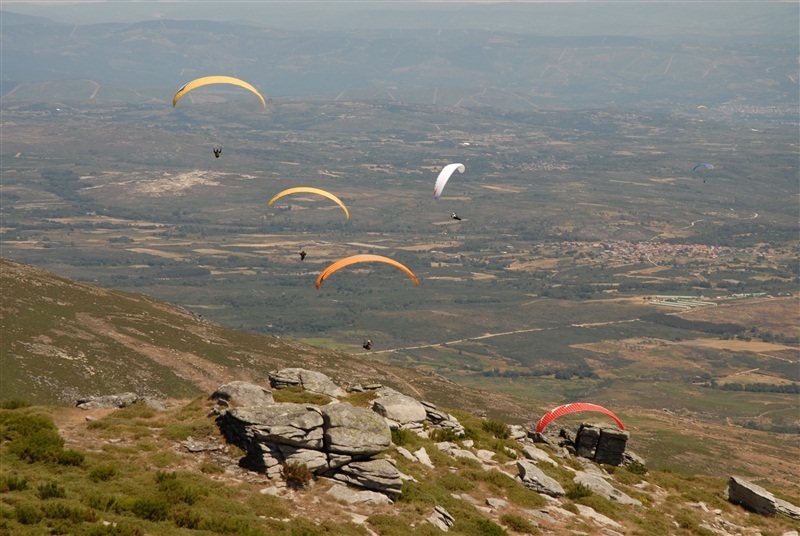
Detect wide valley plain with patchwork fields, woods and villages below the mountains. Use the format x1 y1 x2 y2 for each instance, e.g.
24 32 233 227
2 94 800 430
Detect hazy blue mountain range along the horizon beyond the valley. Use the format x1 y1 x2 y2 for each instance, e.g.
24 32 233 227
0 7 798 110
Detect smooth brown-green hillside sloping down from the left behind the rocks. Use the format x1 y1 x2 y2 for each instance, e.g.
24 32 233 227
0 259 538 420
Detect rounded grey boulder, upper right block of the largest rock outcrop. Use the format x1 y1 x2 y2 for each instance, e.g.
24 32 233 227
321 402 392 457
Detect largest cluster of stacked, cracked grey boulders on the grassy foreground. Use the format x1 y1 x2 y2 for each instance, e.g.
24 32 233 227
212 369 403 498
